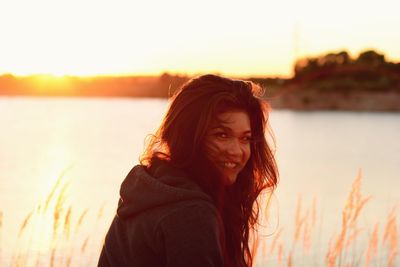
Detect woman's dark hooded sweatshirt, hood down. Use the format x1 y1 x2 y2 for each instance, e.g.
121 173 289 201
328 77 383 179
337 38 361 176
98 162 223 267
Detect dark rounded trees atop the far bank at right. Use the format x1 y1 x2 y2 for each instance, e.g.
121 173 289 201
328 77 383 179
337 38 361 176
291 50 400 92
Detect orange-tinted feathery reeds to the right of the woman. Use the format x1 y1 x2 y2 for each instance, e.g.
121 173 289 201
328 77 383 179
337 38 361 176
259 171 400 267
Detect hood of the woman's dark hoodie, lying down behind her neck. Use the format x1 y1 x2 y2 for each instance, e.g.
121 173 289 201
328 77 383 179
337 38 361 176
117 161 213 218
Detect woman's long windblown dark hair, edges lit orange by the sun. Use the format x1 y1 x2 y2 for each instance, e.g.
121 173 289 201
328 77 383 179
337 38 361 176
141 75 278 267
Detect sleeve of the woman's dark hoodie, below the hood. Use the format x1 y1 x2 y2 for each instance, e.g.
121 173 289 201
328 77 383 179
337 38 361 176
159 204 223 267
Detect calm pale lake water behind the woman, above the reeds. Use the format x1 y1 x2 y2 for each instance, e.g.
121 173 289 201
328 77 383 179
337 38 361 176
0 97 400 265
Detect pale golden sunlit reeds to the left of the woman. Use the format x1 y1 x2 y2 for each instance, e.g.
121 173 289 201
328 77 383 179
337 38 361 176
0 172 105 267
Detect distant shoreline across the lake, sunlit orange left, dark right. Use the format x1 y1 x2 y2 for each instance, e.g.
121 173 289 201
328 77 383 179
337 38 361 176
0 63 400 112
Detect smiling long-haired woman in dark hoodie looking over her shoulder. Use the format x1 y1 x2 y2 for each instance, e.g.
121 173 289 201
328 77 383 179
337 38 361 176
99 75 278 267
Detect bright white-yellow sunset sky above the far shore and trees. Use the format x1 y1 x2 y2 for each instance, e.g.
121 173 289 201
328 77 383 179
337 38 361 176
0 0 400 76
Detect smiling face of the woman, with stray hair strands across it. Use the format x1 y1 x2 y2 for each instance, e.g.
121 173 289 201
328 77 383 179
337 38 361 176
205 110 251 185
